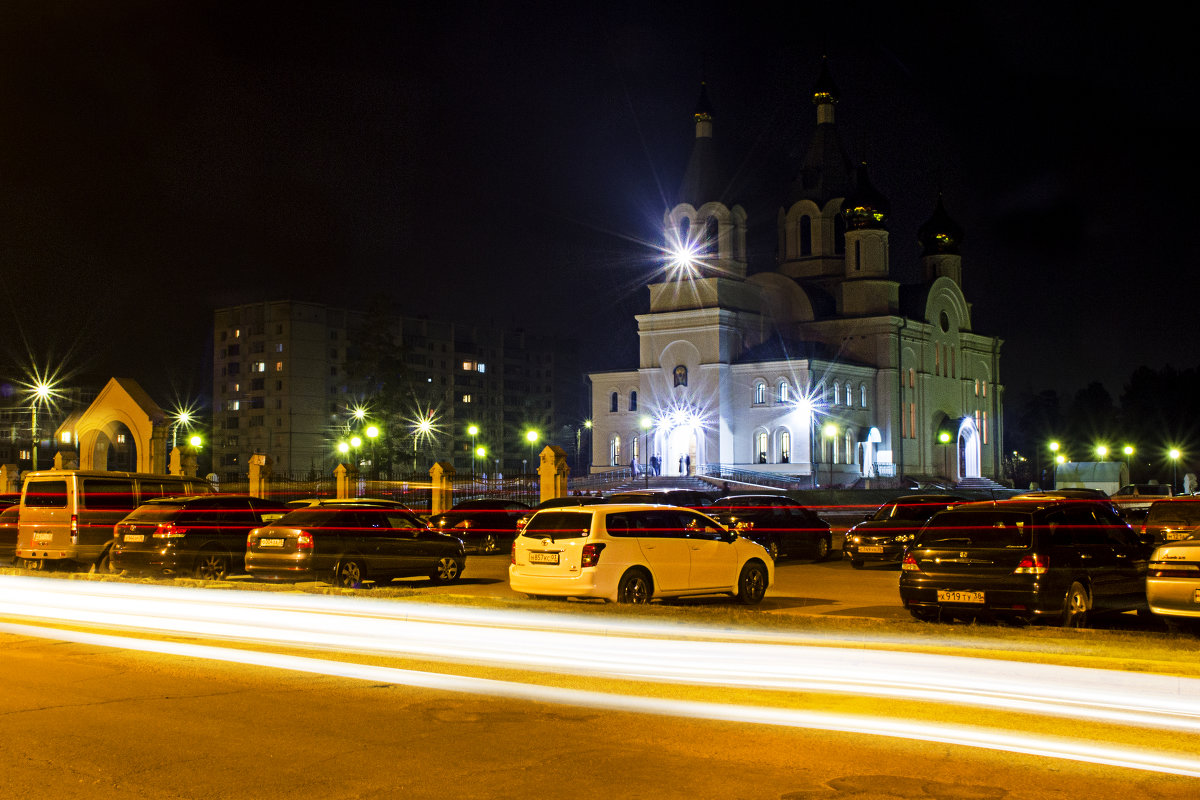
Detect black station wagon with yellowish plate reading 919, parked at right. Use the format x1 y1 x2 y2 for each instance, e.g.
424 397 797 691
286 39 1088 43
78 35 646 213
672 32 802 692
900 499 1153 627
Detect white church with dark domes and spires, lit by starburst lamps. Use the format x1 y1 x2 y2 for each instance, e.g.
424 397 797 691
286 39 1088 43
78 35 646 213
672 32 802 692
589 62 1003 486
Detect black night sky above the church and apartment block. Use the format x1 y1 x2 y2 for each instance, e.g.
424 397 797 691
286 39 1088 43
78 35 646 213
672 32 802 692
0 0 1200 419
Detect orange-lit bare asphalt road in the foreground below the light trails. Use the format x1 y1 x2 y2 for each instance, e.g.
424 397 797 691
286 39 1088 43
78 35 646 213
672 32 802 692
0 633 1200 800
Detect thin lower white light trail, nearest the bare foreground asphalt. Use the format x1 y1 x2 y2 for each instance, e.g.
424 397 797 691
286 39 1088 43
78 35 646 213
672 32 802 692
7 622 1200 777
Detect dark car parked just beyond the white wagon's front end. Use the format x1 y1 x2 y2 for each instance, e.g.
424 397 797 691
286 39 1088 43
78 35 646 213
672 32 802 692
707 494 833 561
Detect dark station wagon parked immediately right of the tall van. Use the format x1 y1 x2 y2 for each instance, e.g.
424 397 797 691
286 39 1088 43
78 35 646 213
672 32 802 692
109 494 292 581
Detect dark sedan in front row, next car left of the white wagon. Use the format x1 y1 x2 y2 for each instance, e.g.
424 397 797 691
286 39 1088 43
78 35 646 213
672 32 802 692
246 500 467 588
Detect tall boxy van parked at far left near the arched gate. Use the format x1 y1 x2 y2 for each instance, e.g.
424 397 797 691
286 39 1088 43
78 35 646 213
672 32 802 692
16 469 212 571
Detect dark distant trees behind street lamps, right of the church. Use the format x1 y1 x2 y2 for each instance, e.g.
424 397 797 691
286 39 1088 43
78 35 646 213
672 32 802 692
1004 366 1200 488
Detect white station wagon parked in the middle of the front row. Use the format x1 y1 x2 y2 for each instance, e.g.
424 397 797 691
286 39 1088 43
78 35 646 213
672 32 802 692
509 504 775 604
